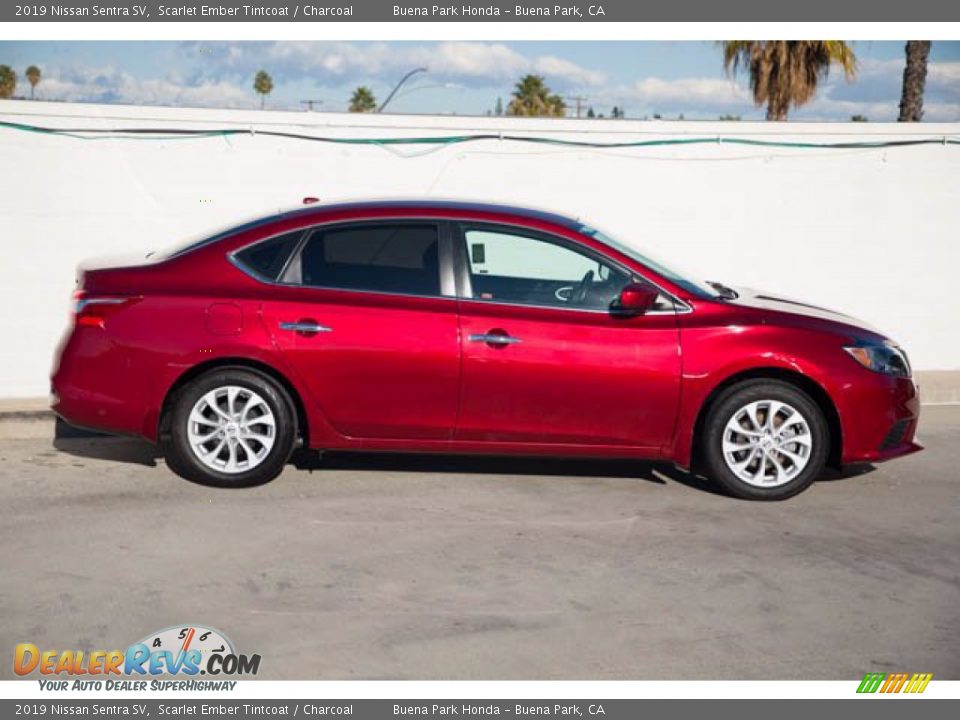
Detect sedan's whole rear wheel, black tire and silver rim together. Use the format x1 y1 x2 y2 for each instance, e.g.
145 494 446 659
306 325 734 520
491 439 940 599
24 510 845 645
164 368 297 487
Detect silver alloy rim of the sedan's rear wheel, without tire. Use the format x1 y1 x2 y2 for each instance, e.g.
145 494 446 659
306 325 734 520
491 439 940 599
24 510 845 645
187 385 277 475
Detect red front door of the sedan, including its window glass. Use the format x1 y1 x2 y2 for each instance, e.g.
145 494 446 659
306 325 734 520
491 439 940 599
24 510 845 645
455 223 680 449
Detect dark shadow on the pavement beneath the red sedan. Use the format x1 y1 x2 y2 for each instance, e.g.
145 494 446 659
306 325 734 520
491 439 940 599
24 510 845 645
53 421 874 495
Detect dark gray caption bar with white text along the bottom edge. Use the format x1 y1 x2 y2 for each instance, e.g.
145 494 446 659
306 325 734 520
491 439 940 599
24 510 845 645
0 704 960 720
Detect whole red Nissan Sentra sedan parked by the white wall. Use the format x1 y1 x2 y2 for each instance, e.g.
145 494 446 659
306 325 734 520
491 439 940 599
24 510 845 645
53 201 920 500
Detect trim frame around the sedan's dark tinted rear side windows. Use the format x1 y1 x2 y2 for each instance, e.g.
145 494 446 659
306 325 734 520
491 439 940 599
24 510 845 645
227 215 458 301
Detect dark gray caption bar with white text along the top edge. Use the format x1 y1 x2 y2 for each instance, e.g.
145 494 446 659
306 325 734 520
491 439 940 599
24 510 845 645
0 0 960 22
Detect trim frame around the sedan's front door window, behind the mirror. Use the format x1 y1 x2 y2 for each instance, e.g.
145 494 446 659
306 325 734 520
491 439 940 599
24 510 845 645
451 220 693 316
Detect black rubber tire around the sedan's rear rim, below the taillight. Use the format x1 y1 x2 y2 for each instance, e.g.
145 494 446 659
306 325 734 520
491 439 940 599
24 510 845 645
163 367 298 487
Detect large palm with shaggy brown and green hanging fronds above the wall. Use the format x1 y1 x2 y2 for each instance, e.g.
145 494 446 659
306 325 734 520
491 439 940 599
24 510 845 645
723 40 857 120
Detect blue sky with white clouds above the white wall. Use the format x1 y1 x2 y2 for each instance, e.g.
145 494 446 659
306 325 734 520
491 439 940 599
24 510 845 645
0 41 960 121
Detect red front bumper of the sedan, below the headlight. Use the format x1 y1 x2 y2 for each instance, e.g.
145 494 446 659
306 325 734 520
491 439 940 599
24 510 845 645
838 370 923 465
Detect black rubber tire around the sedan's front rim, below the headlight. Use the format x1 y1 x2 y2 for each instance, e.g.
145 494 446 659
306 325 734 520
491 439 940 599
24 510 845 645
700 379 830 500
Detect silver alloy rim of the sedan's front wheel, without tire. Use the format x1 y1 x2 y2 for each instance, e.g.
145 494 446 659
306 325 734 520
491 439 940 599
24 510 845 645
723 400 813 488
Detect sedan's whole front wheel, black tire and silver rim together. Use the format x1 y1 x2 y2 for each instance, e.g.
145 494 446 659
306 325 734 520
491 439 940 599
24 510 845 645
702 379 830 500
